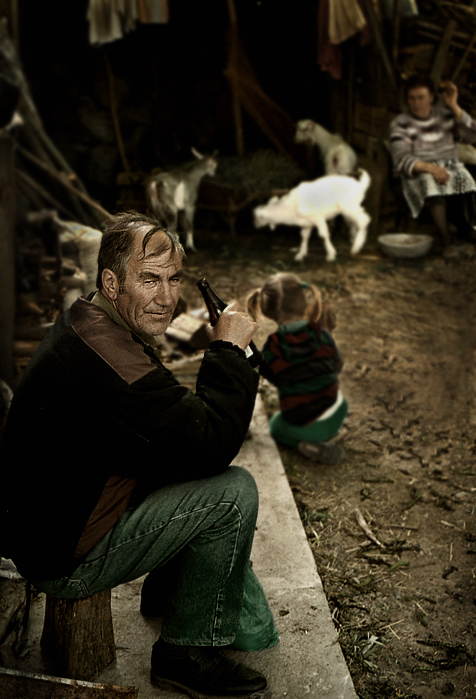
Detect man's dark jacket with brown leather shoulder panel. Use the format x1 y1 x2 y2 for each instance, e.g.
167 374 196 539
0 299 259 581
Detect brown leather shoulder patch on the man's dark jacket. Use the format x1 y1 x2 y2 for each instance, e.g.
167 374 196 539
70 298 155 384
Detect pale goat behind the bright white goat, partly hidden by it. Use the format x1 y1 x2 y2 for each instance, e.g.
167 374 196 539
295 119 357 175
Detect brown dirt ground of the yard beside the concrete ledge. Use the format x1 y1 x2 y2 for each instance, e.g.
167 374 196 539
176 215 476 699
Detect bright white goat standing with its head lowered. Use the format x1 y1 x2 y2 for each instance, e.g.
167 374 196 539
254 170 370 262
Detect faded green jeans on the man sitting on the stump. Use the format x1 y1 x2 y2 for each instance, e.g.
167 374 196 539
35 466 267 646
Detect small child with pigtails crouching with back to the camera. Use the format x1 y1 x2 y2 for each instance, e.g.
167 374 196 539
247 272 348 464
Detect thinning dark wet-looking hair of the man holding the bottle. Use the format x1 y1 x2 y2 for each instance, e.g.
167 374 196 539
96 211 185 289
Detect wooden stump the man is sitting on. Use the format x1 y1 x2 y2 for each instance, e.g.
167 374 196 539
41 590 116 680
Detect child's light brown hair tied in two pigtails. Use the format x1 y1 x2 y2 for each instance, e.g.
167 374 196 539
246 272 323 324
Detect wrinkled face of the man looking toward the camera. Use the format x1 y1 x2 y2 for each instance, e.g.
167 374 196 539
115 231 183 336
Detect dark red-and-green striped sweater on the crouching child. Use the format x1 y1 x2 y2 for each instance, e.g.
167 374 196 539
260 320 343 425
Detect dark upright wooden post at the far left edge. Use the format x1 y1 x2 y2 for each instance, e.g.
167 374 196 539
0 130 16 389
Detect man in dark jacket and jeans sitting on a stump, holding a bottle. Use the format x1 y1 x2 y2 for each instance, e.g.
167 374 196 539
0 213 274 697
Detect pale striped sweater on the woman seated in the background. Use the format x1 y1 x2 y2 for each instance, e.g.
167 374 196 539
389 107 476 177
